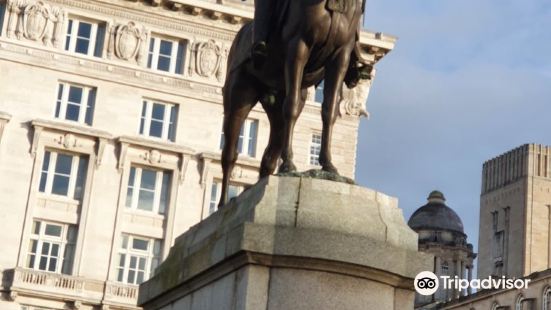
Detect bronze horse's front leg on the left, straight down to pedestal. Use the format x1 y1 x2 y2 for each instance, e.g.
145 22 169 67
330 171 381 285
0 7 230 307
279 39 310 172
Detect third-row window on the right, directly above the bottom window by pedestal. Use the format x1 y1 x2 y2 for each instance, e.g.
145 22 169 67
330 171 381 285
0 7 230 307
126 167 172 214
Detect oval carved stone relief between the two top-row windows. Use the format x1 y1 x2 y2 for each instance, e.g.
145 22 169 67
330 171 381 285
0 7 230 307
108 22 147 63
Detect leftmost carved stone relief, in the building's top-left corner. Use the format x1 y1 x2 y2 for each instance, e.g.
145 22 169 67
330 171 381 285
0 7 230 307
6 0 67 48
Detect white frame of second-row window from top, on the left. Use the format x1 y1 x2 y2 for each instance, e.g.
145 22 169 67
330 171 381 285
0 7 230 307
54 81 97 126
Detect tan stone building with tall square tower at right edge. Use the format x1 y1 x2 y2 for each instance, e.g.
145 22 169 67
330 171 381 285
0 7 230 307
443 144 551 310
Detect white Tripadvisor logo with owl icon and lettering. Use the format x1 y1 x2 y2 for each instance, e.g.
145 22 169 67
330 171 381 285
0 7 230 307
414 271 530 296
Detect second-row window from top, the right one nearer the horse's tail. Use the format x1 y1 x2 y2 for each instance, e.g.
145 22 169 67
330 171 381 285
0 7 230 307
140 100 178 142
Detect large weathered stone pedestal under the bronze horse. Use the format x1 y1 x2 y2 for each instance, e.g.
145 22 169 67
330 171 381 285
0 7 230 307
138 177 432 310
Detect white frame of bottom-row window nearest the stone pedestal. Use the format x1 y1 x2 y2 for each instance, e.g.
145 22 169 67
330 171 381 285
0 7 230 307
114 233 163 285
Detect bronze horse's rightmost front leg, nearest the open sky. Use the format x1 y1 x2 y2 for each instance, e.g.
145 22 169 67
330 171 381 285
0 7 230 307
319 44 353 174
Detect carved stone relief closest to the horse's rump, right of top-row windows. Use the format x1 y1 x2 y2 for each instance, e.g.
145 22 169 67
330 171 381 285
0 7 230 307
189 40 227 82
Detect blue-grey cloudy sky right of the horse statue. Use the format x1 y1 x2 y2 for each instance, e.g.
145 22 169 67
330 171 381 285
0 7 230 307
356 0 551 260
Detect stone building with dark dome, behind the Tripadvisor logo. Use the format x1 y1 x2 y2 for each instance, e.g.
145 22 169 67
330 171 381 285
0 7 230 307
408 191 476 309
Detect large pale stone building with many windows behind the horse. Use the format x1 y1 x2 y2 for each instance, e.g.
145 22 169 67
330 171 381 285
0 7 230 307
0 0 395 310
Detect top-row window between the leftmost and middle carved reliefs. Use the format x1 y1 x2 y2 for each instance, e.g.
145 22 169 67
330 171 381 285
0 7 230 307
65 18 105 57
